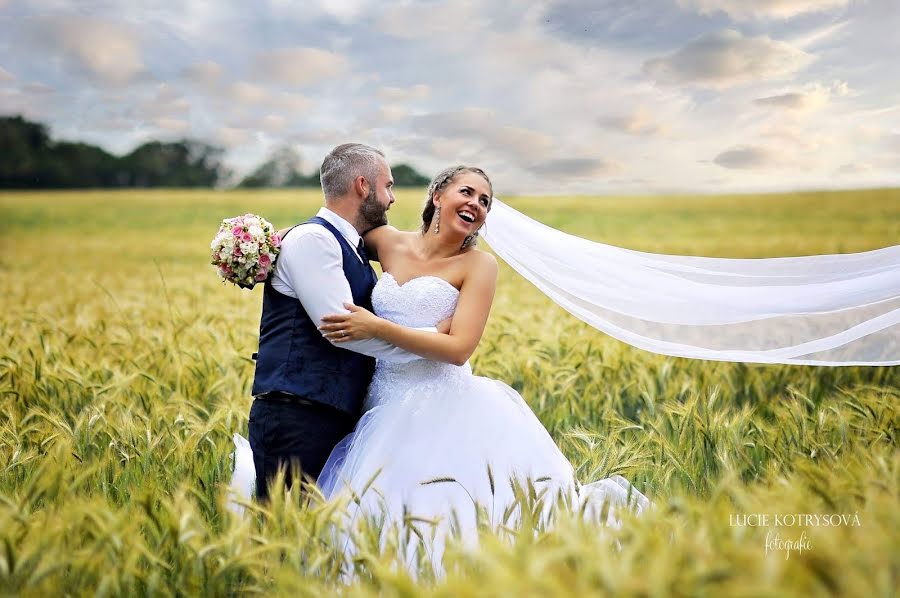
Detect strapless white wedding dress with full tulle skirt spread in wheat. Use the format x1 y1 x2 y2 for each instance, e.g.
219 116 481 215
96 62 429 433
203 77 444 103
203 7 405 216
235 272 649 564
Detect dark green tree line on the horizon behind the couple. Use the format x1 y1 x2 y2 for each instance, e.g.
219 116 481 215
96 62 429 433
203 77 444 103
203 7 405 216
0 116 429 189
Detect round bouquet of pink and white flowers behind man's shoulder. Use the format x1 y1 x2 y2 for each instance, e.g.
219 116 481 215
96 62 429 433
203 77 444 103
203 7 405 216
209 214 281 289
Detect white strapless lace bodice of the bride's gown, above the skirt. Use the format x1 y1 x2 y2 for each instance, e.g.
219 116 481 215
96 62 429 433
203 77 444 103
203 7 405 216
364 272 472 410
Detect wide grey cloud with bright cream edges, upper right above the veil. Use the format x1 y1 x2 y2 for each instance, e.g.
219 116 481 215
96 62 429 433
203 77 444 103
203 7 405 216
644 29 813 88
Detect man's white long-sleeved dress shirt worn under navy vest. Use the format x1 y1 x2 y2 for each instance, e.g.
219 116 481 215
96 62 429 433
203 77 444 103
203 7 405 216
272 207 428 363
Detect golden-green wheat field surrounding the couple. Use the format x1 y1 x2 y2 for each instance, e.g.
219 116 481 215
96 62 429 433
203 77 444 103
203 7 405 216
0 190 900 596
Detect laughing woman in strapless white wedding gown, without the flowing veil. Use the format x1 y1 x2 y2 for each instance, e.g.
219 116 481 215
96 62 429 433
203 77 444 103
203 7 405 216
268 166 649 552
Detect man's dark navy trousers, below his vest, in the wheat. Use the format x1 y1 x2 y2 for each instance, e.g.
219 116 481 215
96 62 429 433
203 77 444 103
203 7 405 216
249 394 357 501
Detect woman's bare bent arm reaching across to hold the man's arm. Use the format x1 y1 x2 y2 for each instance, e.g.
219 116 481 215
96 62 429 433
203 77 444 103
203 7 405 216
319 251 497 365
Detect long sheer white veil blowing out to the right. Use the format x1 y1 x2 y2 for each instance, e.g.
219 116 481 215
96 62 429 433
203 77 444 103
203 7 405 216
481 198 900 366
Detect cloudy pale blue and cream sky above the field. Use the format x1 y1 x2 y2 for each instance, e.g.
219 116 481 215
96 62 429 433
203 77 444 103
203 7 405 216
0 0 900 197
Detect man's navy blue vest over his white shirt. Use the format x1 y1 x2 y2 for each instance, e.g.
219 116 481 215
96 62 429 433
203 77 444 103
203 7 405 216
253 216 377 415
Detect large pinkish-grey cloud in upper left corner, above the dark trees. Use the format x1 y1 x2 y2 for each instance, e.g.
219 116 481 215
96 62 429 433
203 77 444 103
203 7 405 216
33 16 149 86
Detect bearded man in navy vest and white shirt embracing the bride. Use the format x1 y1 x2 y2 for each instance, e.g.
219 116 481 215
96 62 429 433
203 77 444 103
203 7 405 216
249 143 435 501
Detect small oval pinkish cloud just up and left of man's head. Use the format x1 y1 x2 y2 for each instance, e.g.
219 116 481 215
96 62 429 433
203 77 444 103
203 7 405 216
253 48 350 85
